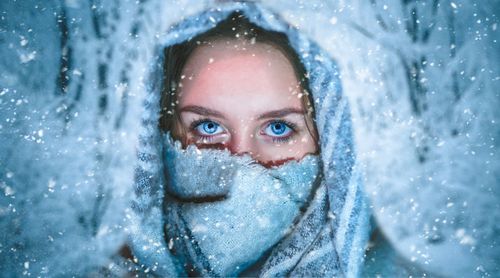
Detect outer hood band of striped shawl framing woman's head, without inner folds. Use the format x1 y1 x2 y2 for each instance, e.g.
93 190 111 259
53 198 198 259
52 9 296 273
130 2 370 277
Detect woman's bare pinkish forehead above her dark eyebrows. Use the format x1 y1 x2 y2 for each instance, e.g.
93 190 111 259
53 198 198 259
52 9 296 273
179 40 301 113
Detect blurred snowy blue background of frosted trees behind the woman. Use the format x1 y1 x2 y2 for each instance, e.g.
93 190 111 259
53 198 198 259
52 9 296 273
0 0 500 277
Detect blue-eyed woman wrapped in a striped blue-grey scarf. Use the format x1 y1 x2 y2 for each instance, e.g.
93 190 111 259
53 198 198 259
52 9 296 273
131 3 369 277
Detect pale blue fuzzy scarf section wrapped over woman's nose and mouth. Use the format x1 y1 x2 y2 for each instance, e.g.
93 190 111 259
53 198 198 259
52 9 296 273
160 132 324 277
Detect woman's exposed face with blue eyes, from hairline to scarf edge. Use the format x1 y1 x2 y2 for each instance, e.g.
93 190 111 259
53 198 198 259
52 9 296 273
177 40 317 165
